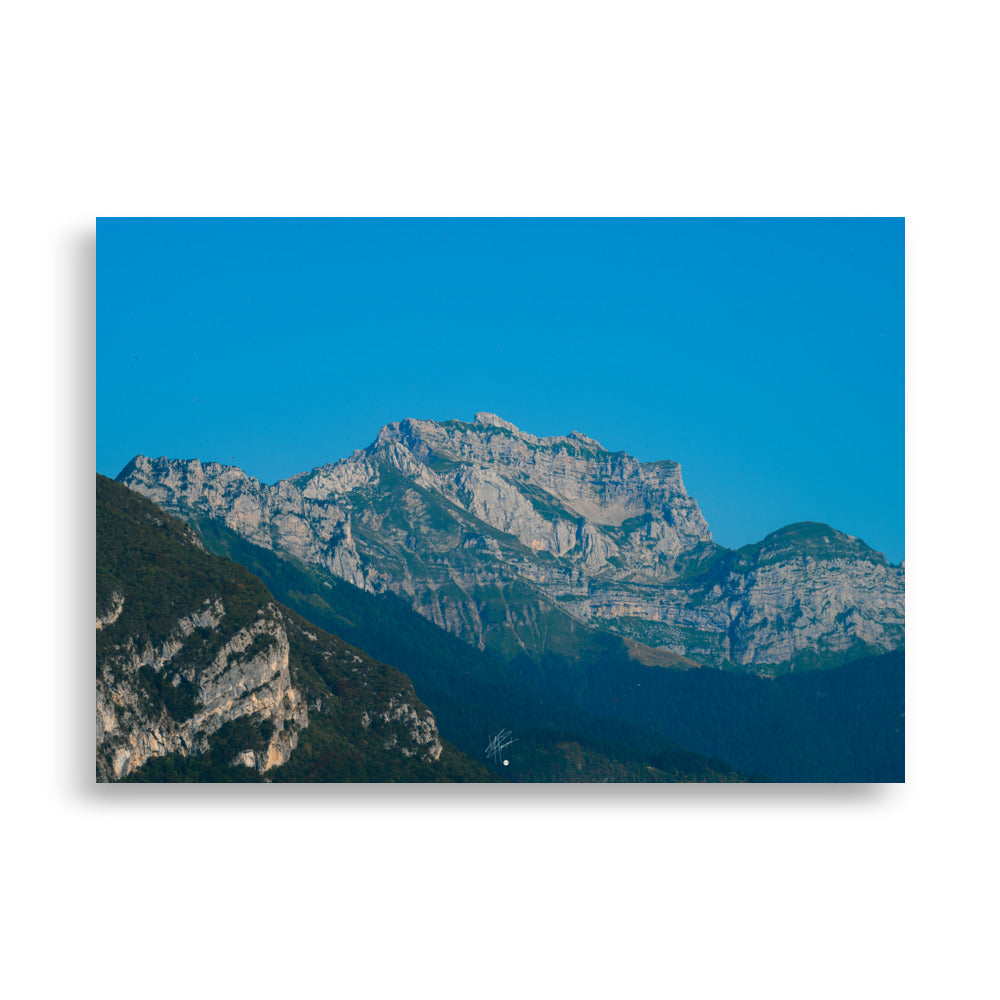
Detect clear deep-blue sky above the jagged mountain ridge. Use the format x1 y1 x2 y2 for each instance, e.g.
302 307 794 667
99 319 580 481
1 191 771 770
97 219 904 562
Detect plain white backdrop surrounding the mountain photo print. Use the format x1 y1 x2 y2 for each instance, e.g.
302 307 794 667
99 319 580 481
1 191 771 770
0 0 998 998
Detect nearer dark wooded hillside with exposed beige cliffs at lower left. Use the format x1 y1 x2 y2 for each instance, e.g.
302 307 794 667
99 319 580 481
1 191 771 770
96 469 460 781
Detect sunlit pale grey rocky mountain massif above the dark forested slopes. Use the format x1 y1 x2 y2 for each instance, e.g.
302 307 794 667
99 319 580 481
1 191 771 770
119 413 904 673
